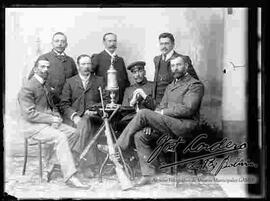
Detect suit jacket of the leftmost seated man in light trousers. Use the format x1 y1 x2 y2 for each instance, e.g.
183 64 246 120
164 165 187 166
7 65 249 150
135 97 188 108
18 77 57 137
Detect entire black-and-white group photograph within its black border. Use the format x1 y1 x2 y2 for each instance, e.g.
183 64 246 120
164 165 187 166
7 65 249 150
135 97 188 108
3 6 263 199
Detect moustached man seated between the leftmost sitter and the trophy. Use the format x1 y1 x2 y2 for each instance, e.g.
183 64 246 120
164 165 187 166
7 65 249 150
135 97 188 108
60 54 104 177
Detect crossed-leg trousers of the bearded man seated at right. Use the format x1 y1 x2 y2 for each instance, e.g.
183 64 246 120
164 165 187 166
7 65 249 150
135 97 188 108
116 109 198 175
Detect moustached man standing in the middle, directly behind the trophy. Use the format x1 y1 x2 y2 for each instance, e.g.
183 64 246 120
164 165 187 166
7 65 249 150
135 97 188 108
93 33 130 104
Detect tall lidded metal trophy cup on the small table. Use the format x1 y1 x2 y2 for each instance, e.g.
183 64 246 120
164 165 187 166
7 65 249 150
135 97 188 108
106 57 119 109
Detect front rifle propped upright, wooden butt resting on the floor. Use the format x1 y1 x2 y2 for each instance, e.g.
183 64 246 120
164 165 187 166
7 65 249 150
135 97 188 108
99 87 133 190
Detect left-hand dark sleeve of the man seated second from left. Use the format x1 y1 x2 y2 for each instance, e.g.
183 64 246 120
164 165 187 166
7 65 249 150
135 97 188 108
60 81 76 119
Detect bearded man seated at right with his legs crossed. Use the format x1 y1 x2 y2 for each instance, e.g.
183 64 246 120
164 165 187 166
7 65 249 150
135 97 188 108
102 55 204 185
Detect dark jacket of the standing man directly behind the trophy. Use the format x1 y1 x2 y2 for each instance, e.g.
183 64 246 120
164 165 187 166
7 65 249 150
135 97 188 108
92 50 130 104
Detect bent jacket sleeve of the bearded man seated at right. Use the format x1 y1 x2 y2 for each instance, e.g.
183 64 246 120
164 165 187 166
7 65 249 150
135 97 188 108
163 82 204 118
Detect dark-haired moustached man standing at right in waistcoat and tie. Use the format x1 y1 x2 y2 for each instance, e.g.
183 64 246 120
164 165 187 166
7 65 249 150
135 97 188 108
153 33 199 104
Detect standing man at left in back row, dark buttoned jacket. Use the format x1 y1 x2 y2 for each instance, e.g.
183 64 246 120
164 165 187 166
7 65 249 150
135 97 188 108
28 32 78 106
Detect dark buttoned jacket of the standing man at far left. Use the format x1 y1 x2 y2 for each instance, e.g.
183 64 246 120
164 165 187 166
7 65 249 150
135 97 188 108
28 50 78 104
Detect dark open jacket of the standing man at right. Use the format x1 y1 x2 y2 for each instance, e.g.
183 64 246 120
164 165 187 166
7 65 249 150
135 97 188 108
153 51 199 102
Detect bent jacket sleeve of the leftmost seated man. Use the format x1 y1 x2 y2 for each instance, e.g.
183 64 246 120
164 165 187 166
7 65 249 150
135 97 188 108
18 87 53 124
